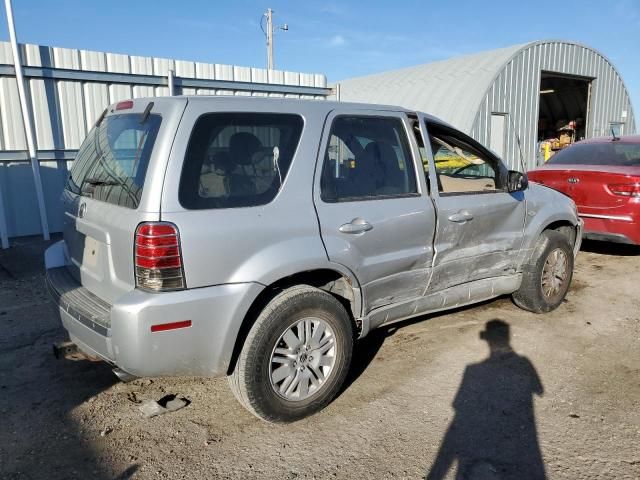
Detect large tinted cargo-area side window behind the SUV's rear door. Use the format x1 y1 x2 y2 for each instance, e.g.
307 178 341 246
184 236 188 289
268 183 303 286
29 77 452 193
179 113 303 209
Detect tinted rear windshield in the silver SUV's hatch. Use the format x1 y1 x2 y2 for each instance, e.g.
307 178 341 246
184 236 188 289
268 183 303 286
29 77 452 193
66 113 162 209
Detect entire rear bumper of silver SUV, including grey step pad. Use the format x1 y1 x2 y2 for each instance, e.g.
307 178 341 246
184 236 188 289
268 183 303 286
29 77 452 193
47 242 263 376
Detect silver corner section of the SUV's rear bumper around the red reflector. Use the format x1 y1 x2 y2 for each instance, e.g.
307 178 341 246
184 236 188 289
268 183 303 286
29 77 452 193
111 283 263 376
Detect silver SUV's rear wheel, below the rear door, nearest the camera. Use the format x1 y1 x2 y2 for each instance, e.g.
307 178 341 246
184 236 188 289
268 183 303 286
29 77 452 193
228 285 353 423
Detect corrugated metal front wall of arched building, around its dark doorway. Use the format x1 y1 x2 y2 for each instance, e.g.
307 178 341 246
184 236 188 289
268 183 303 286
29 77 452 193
470 42 636 169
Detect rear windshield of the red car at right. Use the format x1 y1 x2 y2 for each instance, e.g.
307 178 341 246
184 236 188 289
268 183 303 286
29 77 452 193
547 142 640 167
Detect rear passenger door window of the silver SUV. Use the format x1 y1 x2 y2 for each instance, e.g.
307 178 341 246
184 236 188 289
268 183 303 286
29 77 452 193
320 116 418 202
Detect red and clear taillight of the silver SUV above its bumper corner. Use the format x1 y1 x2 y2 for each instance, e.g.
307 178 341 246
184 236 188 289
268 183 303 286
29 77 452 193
134 222 185 292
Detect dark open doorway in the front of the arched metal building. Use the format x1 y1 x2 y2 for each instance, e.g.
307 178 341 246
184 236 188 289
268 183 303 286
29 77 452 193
538 72 592 163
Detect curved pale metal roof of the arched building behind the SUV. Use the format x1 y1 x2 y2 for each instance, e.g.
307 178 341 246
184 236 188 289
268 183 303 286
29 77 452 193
339 44 529 131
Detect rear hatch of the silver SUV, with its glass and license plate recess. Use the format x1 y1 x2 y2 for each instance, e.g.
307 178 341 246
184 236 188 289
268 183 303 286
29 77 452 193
62 98 187 303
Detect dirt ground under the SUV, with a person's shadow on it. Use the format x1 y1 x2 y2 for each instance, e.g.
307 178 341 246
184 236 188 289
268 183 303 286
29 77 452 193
0 236 640 479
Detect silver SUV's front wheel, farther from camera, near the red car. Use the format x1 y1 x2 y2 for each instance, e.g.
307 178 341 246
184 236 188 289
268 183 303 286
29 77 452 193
512 230 573 313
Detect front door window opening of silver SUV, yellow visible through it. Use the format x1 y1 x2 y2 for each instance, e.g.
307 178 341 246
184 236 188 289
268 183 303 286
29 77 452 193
429 130 501 193
